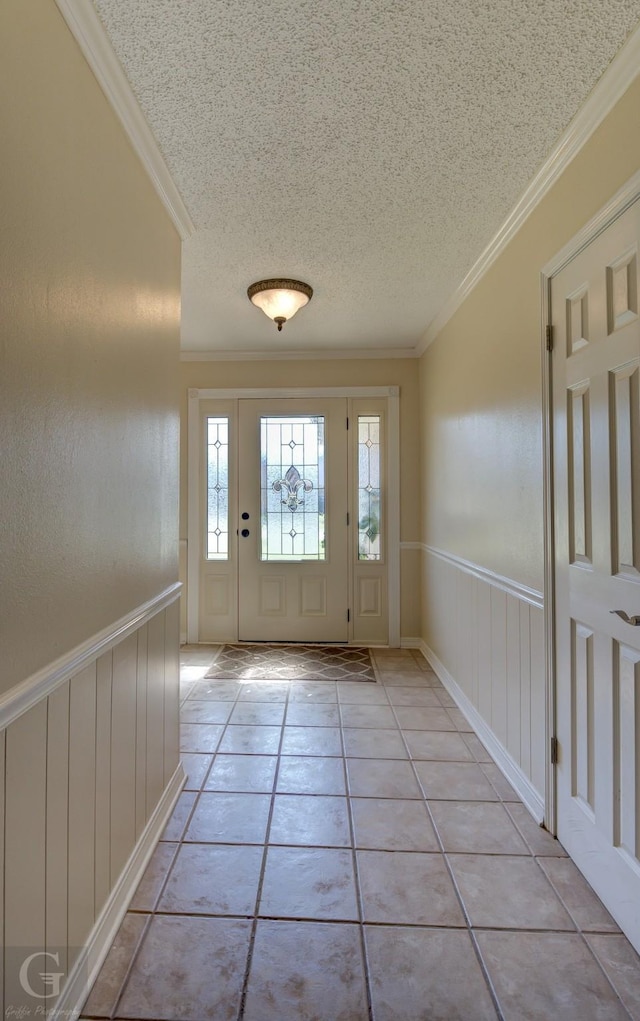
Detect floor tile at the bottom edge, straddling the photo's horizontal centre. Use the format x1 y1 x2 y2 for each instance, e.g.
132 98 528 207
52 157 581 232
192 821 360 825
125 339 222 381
244 921 368 1021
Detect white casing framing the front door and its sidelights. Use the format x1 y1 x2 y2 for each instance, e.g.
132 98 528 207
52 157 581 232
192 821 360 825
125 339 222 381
187 386 400 647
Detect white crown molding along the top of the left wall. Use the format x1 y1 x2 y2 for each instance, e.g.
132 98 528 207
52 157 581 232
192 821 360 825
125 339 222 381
55 0 195 241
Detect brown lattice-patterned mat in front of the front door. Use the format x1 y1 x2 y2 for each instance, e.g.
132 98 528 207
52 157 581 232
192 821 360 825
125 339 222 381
206 644 376 683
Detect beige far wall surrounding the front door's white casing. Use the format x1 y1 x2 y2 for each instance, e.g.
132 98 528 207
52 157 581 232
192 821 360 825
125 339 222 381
180 355 421 637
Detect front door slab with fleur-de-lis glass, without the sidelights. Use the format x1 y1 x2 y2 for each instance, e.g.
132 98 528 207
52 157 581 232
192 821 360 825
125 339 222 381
238 397 349 642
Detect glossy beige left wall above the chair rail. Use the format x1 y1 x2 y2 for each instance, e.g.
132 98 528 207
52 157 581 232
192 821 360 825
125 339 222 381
0 0 180 692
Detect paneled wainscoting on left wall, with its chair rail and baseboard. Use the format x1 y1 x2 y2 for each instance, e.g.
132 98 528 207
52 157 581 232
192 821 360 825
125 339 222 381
0 585 184 1017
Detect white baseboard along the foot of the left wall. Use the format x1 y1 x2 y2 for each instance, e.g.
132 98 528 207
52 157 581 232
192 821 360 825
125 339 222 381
58 765 187 1021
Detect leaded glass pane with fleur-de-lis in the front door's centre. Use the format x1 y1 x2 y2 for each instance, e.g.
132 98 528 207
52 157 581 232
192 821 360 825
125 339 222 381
260 415 326 561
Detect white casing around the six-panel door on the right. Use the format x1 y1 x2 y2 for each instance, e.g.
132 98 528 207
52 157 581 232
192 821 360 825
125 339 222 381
540 171 640 834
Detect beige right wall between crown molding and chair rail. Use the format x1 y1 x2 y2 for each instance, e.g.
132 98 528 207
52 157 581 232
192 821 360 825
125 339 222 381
421 80 640 590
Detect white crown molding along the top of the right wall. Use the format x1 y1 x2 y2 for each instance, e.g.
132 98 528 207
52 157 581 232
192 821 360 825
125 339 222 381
416 19 640 356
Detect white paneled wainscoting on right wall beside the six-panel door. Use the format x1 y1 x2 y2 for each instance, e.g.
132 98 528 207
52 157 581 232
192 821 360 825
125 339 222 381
421 545 547 822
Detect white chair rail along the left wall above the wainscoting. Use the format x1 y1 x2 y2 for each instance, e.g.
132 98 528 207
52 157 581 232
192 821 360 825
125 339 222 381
0 582 182 730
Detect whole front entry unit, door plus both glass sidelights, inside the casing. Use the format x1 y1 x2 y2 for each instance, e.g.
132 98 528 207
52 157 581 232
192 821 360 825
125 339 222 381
188 391 399 644
